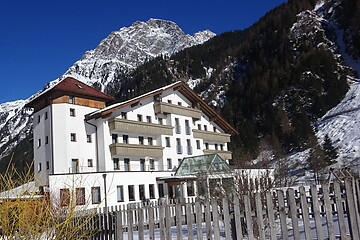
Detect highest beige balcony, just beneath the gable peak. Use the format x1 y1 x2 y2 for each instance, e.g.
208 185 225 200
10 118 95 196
154 102 201 119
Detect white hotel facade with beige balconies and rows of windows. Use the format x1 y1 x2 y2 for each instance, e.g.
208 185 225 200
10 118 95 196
30 79 231 207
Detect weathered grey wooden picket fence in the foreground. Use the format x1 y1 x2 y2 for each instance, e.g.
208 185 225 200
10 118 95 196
79 179 360 240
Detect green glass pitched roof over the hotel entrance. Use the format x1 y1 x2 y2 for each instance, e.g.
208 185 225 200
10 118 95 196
175 154 231 176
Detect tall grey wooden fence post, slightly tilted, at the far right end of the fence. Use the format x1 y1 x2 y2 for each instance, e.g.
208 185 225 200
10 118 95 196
345 179 360 239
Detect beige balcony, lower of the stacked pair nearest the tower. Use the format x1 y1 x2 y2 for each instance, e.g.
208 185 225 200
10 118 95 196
110 143 164 157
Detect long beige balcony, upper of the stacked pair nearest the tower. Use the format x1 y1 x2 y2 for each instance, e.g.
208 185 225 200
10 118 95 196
109 118 173 135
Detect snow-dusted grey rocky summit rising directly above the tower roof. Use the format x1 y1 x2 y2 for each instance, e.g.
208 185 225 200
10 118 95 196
65 19 215 91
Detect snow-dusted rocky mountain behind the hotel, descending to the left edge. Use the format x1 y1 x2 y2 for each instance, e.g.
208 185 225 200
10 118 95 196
0 19 215 171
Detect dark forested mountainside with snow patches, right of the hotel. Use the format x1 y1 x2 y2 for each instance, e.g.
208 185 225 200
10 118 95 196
108 0 360 171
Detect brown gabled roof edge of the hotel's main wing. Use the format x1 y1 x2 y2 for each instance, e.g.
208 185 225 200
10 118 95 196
86 81 238 134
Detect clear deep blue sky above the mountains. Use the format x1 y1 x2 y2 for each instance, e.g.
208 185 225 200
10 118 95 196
0 0 285 103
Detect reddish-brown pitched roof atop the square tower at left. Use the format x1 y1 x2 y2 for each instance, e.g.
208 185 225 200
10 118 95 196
26 77 114 107
